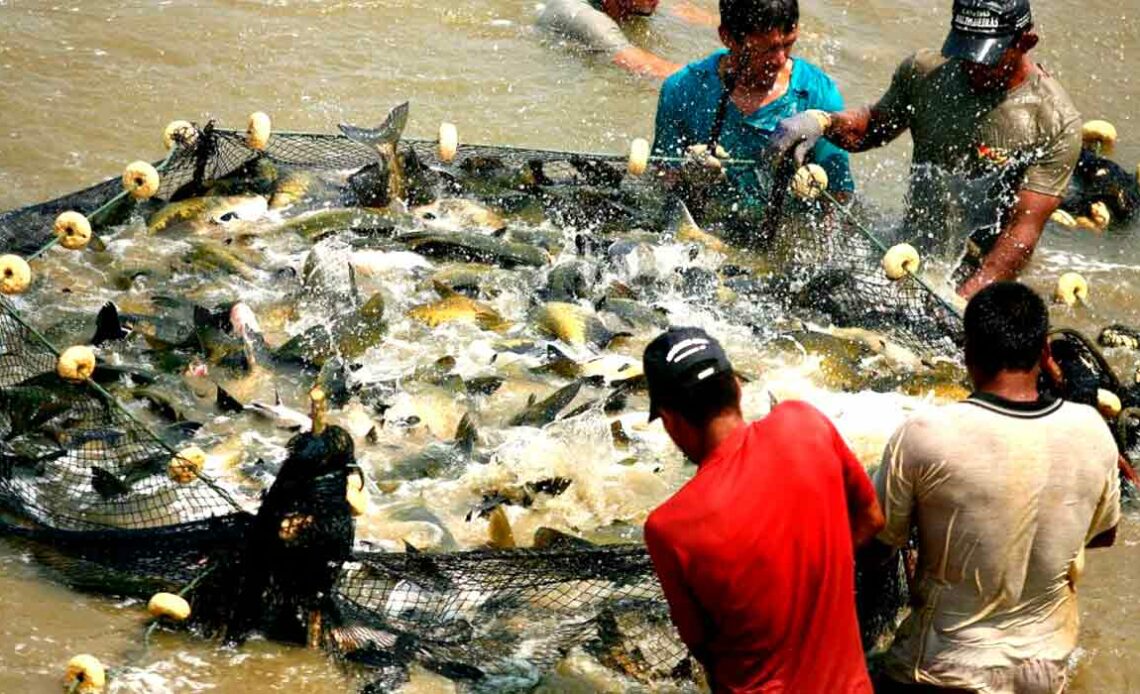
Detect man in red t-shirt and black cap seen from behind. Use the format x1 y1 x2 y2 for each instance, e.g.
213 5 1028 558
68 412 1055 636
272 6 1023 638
644 328 882 694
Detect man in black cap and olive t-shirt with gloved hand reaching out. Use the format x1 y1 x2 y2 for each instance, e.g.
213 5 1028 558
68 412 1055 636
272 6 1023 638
772 0 1081 299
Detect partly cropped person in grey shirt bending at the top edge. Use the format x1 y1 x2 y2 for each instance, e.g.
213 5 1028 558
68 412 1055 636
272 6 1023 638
538 0 715 79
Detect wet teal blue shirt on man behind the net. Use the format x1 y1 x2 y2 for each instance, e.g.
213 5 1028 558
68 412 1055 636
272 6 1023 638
653 49 855 201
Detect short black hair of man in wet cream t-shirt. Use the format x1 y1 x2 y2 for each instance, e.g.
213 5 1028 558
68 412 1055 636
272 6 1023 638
963 281 1049 376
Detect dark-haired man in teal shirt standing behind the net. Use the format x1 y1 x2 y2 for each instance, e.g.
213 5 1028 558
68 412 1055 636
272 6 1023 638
653 0 855 206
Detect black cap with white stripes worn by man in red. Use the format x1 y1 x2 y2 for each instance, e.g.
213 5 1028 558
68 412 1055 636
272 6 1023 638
642 328 733 422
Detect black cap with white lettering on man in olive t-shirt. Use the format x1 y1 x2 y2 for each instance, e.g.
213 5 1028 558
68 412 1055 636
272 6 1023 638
942 0 1033 65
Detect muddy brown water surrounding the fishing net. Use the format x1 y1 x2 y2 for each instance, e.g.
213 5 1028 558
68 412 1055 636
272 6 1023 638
0 0 1140 692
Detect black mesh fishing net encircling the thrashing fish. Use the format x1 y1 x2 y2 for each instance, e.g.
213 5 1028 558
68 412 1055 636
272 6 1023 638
0 119 925 691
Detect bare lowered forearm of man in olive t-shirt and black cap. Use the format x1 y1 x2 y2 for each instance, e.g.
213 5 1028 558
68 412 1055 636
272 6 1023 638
958 190 1061 299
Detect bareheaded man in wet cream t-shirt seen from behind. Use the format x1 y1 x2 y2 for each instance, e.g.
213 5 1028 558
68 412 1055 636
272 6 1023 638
876 283 1121 694
